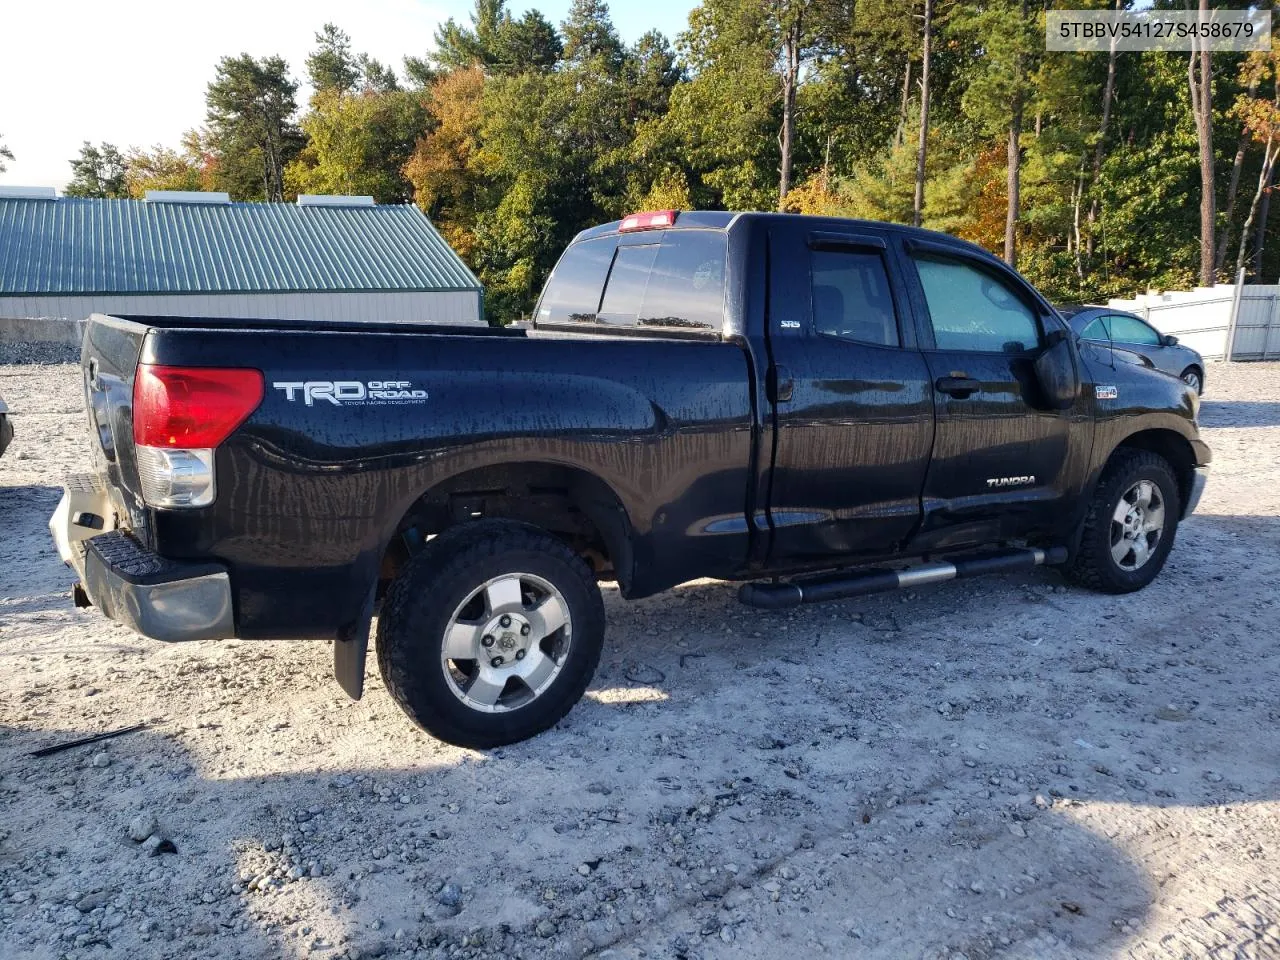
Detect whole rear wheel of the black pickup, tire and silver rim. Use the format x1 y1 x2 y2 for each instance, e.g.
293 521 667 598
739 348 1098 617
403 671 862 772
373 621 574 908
378 521 604 748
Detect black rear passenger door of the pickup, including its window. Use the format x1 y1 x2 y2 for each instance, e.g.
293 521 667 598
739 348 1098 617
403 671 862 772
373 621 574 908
768 220 933 566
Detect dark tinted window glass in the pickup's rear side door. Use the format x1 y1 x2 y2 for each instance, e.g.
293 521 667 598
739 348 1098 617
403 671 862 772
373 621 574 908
810 250 899 347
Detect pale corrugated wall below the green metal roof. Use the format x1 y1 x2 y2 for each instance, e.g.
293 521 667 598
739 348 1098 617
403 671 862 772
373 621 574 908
0 291 481 324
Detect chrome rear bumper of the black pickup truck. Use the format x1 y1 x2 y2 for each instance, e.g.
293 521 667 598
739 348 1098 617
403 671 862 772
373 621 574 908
49 477 236 643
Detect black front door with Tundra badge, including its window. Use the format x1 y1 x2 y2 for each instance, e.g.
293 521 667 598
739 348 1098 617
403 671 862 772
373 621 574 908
900 238 1088 549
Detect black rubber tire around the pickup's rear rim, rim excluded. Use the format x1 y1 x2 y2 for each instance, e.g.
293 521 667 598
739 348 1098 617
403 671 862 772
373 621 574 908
378 520 604 749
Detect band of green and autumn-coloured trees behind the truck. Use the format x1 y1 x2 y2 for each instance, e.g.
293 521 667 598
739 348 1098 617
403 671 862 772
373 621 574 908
70 0 1280 321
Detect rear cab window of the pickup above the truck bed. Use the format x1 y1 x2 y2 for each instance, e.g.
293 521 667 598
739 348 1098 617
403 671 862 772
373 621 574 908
536 230 726 333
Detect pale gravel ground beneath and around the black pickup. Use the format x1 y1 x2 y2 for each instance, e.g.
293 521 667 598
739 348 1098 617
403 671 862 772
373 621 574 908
0 355 1280 960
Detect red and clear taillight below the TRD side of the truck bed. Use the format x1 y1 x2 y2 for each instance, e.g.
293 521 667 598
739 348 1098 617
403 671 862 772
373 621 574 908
133 364 262 507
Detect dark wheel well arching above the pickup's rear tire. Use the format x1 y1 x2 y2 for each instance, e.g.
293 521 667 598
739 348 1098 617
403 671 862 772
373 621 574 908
379 462 631 593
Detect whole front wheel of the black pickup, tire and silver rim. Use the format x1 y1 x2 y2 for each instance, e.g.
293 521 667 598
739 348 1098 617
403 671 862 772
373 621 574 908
1065 449 1181 594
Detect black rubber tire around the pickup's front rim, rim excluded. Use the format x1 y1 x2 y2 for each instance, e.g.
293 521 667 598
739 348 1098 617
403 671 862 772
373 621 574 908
1062 449 1183 594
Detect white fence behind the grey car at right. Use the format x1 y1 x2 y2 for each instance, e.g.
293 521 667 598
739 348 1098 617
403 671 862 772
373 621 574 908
1107 283 1280 360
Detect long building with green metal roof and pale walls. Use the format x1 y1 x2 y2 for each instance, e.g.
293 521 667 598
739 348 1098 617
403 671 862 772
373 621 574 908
0 186 484 324
